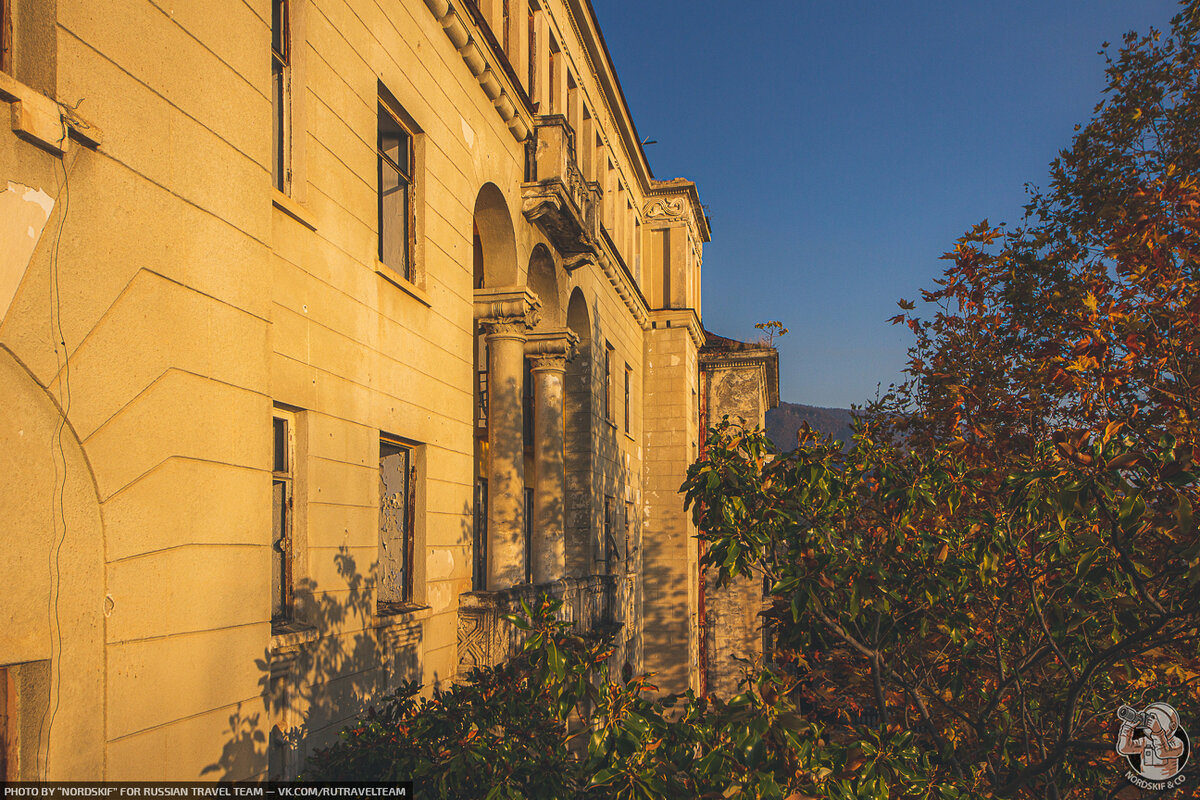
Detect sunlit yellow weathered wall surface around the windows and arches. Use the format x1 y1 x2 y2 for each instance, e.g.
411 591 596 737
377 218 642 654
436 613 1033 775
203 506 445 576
0 0 729 780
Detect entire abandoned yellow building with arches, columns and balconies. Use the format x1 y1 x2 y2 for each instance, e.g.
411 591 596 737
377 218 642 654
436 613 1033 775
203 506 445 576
0 0 778 780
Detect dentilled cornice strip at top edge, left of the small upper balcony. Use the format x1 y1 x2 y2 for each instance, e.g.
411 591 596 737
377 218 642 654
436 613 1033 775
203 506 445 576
425 0 533 142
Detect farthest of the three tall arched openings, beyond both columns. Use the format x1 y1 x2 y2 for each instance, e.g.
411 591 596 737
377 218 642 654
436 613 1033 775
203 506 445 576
563 289 594 576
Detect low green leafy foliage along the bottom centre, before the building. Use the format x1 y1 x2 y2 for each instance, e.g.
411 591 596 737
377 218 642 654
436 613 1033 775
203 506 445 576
305 600 929 800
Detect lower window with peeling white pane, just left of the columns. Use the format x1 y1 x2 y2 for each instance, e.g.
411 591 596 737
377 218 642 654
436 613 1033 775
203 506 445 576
379 435 416 610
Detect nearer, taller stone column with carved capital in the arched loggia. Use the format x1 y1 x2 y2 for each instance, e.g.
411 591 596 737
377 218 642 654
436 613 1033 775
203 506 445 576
475 287 541 591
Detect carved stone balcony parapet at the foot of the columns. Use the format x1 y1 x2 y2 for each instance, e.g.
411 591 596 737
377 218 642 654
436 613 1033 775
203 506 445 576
458 575 617 674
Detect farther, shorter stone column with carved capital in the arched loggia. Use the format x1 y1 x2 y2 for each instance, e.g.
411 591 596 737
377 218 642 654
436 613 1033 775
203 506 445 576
526 330 578 583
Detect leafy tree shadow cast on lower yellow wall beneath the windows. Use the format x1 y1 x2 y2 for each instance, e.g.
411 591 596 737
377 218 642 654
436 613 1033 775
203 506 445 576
202 546 436 781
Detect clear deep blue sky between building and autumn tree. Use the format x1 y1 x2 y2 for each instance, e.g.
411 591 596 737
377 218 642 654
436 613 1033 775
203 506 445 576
593 0 1177 407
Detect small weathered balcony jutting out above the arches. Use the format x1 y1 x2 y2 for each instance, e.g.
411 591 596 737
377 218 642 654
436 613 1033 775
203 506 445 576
521 114 600 254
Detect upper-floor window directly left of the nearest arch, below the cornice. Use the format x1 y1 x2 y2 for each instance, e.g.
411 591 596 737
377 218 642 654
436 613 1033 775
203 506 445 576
378 101 414 281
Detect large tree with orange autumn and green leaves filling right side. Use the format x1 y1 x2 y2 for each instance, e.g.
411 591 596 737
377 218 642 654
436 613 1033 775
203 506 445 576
684 1 1200 798
